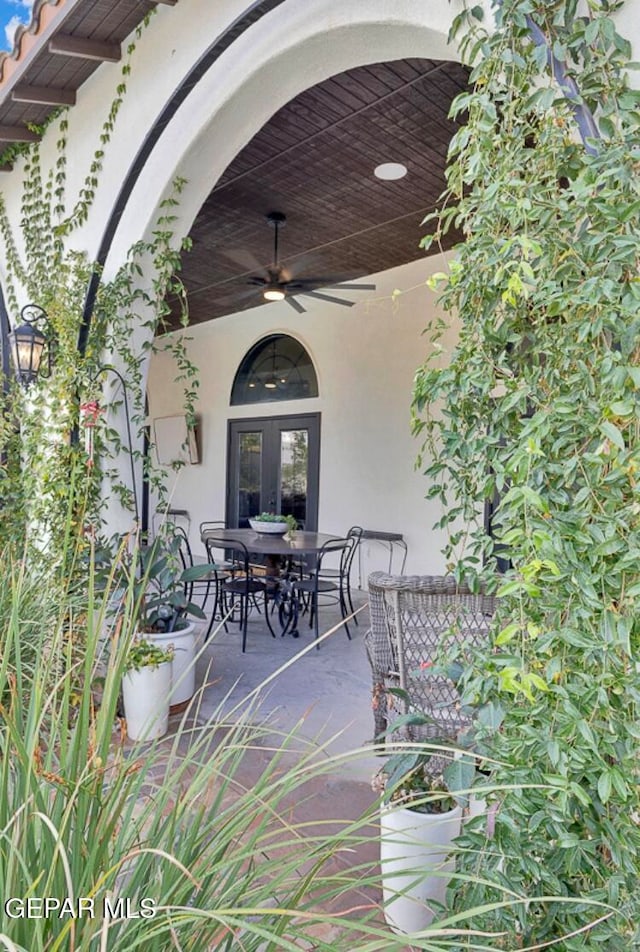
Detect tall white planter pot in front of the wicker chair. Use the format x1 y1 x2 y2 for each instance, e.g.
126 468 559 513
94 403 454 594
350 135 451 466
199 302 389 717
380 806 462 933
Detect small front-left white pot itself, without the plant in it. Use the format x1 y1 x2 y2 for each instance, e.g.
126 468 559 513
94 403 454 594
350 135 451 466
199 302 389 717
122 661 171 740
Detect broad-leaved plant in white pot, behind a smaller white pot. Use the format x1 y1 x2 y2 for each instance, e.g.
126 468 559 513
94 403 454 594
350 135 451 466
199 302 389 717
137 538 211 713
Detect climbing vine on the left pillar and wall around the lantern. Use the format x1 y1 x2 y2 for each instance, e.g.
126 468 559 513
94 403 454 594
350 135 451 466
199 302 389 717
0 11 198 565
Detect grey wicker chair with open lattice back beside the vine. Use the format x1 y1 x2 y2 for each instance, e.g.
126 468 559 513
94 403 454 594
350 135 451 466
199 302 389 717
365 572 495 740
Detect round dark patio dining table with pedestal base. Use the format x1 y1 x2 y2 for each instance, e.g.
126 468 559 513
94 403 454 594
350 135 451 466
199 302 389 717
201 529 346 638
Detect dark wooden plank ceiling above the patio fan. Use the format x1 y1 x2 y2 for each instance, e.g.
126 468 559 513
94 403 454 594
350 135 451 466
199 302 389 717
182 59 467 323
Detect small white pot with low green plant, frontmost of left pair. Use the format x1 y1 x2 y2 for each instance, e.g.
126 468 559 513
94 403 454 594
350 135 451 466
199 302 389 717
122 637 173 740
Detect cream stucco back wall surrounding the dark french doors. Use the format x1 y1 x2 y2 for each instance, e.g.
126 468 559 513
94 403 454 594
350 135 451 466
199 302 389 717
149 258 454 581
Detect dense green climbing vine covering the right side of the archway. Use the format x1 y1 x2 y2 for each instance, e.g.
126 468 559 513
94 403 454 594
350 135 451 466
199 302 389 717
414 0 640 952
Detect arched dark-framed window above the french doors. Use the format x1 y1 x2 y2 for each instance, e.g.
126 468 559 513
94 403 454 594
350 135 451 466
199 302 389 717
231 334 318 406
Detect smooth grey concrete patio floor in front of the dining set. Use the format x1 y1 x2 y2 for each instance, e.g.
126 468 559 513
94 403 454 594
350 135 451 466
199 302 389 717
196 591 381 784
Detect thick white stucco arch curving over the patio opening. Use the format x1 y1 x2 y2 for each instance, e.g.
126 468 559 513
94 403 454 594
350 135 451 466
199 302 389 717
105 0 458 276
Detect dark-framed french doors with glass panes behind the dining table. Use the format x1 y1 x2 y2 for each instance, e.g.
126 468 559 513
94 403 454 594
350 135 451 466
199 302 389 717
226 413 320 530
